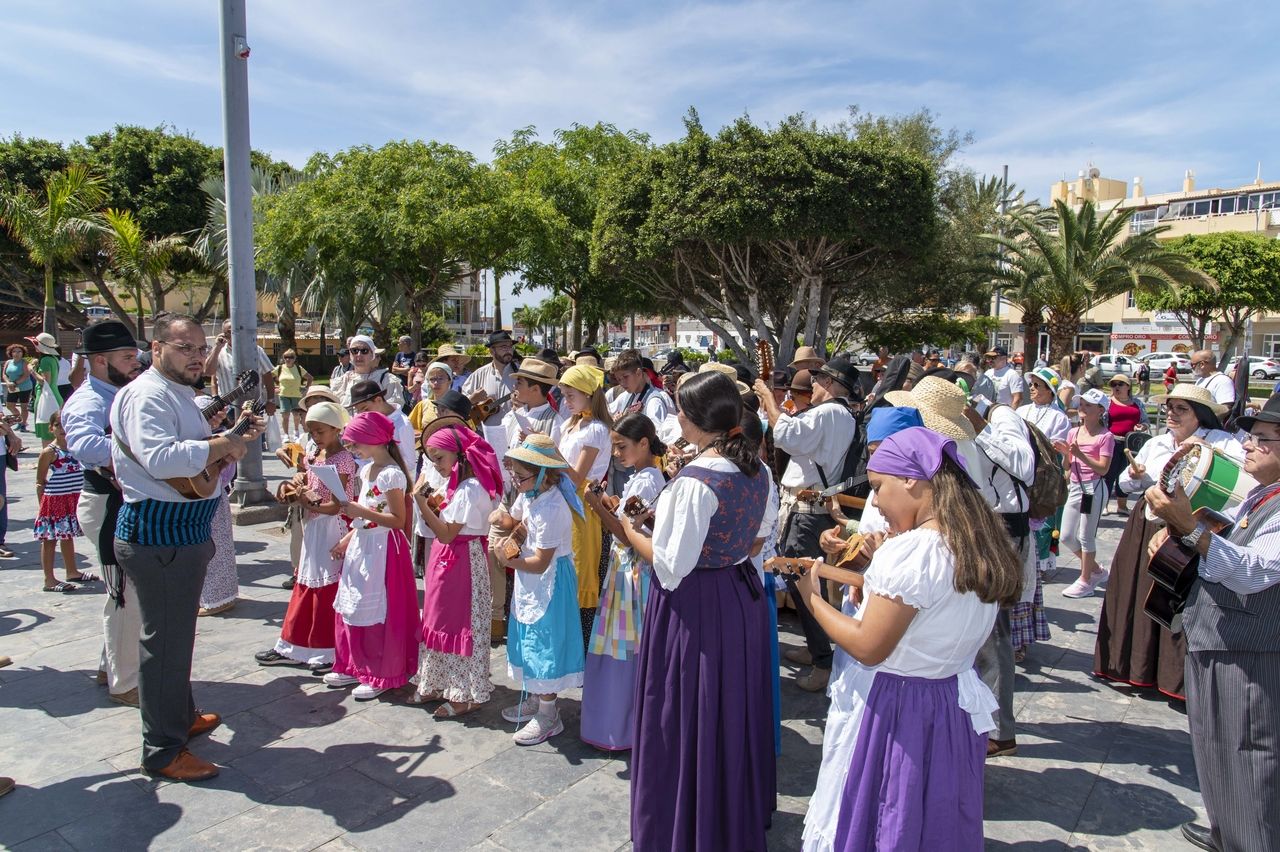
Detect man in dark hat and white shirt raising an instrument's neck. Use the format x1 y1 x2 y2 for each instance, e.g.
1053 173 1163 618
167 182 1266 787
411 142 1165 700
754 358 863 692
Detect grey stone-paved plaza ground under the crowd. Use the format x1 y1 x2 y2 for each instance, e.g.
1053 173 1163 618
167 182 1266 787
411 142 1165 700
0 450 1203 852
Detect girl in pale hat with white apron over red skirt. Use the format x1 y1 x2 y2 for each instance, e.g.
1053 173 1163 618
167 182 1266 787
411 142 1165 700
253 402 360 674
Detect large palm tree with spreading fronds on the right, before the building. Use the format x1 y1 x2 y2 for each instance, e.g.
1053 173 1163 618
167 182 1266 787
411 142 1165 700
991 201 1212 361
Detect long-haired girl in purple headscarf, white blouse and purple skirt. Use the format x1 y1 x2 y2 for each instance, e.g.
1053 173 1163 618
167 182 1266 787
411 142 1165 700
799 427 1021 852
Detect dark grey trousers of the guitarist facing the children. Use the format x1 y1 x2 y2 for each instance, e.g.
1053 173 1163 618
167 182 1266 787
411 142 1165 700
115 539 214 770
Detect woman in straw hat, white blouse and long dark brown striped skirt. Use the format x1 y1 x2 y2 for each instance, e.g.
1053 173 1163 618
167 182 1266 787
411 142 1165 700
1093 383 1244 698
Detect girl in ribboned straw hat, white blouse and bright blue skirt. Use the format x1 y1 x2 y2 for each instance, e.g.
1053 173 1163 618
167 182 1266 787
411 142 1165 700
500 435 585 746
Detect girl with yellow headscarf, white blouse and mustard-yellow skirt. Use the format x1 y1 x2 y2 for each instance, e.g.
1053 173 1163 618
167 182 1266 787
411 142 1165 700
559 363 613 646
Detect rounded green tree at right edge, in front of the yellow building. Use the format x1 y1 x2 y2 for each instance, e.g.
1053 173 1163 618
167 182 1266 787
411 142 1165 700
1134 232 1280 368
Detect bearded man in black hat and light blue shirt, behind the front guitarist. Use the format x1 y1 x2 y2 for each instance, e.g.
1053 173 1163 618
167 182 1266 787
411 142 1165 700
63 320 142 707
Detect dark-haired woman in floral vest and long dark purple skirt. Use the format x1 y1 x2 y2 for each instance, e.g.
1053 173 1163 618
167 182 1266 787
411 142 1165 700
625 372 776 852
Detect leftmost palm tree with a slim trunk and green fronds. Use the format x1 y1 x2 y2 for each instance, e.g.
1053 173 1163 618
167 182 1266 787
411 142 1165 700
0 165 106 334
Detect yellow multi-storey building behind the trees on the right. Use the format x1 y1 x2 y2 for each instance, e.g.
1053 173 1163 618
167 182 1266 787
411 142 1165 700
997 168 1280 357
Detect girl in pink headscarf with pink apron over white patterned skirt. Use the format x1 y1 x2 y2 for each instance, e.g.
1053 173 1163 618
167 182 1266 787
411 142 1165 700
410 423 502 719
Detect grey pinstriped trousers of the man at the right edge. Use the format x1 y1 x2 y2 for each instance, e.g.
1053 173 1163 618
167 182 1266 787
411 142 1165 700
1187 651 1280 852
